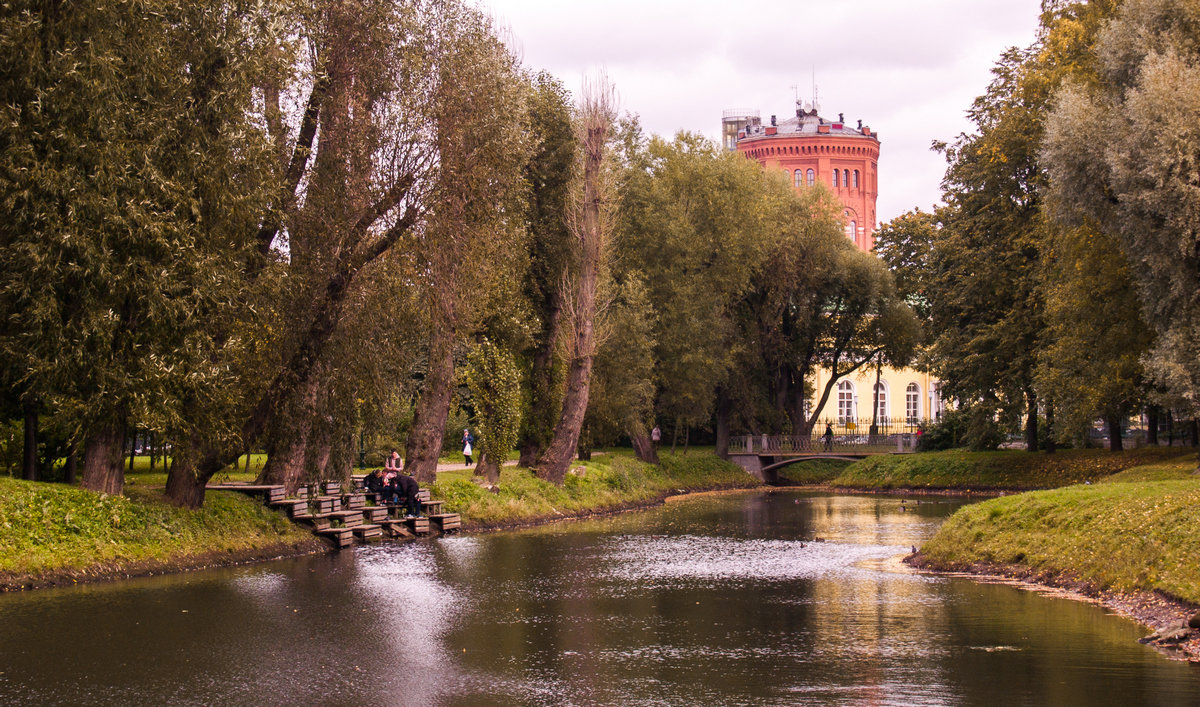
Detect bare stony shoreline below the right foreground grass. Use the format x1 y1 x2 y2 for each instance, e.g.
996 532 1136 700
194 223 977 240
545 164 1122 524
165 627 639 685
901 552 1200 664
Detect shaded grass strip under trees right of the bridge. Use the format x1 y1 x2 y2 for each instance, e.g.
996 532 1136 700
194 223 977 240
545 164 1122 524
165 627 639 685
829 448 1180 490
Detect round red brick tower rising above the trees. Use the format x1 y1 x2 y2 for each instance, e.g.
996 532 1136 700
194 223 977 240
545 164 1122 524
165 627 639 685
737 106 880 251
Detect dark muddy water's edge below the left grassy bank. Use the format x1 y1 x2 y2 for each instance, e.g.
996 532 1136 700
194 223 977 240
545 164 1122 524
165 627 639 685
0 537 332 592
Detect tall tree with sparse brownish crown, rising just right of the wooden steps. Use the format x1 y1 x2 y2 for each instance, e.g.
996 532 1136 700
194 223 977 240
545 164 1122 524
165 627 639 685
404 6 529 481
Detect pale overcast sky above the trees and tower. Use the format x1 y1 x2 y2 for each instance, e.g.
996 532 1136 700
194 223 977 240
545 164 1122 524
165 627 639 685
478 0 1039 222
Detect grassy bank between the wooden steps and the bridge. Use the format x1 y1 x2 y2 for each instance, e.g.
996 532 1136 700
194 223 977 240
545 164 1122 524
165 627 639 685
433 451 758 528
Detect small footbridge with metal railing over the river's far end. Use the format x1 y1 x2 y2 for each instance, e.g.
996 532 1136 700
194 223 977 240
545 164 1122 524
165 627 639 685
730 433 917 484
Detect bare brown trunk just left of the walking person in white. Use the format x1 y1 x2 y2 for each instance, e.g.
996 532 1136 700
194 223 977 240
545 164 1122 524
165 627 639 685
404 308 455 484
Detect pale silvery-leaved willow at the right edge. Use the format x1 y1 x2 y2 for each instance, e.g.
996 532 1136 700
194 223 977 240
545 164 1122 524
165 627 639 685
1042 0 1200 451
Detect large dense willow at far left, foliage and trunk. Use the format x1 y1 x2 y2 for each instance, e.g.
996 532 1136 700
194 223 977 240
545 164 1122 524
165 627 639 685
0 1 284 493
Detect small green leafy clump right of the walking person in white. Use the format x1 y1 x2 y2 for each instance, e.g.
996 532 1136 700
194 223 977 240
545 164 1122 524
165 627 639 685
466 338 521 463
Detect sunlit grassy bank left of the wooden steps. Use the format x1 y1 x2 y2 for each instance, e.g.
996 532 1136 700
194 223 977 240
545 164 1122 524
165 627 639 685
0 477 313 588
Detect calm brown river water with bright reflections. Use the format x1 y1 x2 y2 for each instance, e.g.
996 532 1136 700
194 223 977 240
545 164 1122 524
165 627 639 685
0 492 1200 706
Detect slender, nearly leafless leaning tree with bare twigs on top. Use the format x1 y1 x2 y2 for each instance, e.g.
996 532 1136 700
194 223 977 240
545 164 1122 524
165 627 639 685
535 79 617 484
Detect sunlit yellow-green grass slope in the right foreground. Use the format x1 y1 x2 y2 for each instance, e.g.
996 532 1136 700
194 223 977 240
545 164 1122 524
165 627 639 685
922 479 1200 603
